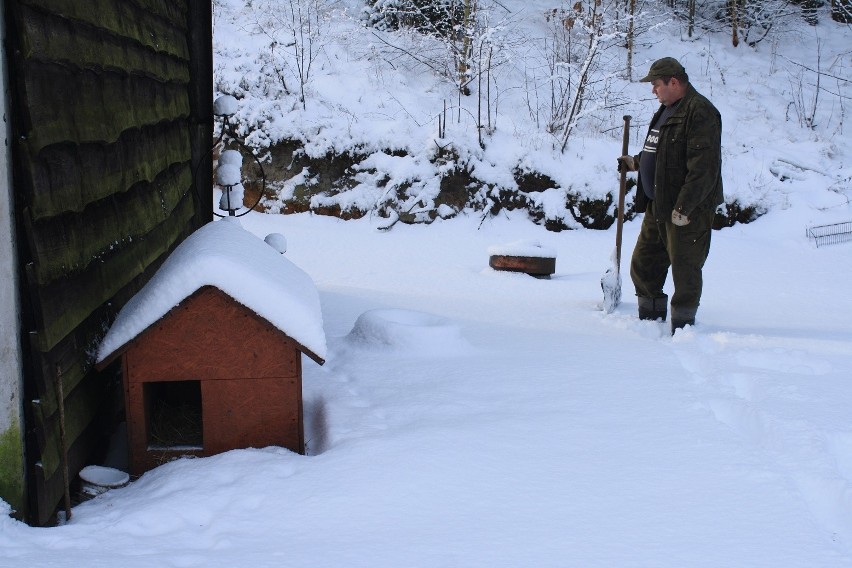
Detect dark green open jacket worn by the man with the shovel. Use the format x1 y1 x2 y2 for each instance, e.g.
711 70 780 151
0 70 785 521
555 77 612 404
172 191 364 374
634 84 724 221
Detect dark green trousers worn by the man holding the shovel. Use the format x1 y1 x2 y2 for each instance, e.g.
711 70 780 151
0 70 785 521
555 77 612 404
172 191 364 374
630 201 716 321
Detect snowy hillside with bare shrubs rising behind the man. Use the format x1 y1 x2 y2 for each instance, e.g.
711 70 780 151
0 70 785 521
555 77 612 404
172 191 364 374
208 0 852 223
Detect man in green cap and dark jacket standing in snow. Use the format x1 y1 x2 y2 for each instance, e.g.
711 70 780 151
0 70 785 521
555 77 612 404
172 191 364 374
618 57 724 333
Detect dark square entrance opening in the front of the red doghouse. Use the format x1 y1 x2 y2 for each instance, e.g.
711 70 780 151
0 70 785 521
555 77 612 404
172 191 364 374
144 381 204 450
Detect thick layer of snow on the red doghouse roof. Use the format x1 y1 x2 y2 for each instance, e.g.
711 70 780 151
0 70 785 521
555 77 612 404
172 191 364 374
97 217 326 364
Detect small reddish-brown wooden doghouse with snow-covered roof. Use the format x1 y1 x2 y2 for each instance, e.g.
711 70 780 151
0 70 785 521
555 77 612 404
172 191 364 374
98 219 325 475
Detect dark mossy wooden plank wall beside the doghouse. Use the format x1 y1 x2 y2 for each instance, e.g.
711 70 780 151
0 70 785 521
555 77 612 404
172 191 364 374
5 0 212 524
